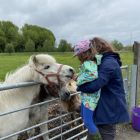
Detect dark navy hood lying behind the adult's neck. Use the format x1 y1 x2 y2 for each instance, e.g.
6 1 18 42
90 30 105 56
102 52 122 66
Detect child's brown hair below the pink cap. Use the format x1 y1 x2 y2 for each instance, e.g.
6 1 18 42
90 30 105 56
77 47 96 63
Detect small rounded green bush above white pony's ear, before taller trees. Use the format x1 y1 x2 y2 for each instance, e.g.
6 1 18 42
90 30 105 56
25 39 35 52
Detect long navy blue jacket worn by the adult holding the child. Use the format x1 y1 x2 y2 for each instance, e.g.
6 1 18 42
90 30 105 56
77 52 129 124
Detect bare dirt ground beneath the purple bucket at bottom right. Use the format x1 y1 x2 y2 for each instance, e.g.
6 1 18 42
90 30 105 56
115 124 140 140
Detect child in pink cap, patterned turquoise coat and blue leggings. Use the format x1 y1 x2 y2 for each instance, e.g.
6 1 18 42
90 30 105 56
74 40 101 134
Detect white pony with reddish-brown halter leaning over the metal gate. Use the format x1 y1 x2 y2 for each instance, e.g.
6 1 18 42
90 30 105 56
0 54 74 140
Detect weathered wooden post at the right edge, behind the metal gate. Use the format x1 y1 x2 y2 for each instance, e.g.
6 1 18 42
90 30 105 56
133 41 140 105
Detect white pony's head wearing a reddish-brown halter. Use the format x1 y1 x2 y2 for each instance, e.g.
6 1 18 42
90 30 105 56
29 54 74 85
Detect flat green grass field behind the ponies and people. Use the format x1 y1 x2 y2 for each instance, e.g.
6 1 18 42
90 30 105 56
0 52 133 81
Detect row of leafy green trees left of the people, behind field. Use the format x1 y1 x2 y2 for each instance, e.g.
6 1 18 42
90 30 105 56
0 21 72 53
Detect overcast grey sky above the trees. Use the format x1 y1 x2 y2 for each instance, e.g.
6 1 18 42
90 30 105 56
0 0 140 44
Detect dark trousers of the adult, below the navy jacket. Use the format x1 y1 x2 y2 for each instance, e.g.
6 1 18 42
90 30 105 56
97 124 116 140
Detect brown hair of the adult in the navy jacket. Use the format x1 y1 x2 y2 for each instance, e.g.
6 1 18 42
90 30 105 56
91 37 114 54
